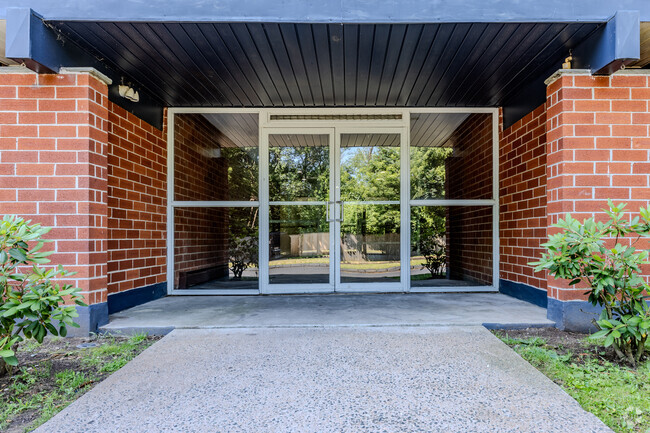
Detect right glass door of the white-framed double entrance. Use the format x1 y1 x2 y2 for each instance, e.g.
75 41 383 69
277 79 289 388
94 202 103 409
336 130 403 292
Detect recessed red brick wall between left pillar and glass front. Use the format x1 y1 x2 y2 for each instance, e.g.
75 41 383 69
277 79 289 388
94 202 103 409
108 102 167 294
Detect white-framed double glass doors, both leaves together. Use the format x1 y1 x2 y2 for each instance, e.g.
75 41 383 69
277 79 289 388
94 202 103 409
259 127 402 293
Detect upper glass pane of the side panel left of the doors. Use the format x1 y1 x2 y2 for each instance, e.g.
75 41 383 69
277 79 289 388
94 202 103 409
174 113 259 201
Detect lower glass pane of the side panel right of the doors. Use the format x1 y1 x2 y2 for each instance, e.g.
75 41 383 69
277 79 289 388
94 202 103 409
411 206 493 287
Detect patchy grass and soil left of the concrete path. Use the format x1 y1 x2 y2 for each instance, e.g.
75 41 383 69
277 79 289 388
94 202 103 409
0 335 158 432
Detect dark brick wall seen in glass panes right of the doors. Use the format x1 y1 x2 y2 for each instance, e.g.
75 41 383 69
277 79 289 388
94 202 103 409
445 114 492 284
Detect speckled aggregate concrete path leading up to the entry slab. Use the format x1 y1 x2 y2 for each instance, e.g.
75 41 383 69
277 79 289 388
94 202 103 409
36 326 611 433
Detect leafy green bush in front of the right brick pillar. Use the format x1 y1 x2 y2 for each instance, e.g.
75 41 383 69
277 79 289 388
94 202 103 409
530 200 650 367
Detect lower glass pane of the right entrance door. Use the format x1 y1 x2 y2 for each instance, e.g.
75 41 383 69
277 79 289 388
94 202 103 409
340 204 400 283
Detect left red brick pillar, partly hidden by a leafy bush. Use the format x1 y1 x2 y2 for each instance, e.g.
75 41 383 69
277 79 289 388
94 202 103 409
0 67 108 333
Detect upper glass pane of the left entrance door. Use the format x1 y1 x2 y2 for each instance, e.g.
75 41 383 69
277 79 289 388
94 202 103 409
269 134 330 201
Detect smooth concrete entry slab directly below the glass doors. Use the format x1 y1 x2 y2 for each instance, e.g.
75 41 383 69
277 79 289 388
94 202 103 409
101 293 554 333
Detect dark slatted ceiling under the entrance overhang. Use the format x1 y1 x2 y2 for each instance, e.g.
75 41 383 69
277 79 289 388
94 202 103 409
50 22 599 107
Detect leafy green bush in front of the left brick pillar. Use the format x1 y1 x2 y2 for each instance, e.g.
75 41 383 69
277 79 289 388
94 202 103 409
0 216 86 375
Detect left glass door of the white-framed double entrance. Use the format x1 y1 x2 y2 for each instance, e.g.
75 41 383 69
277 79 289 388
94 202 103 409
261 128 335 293
